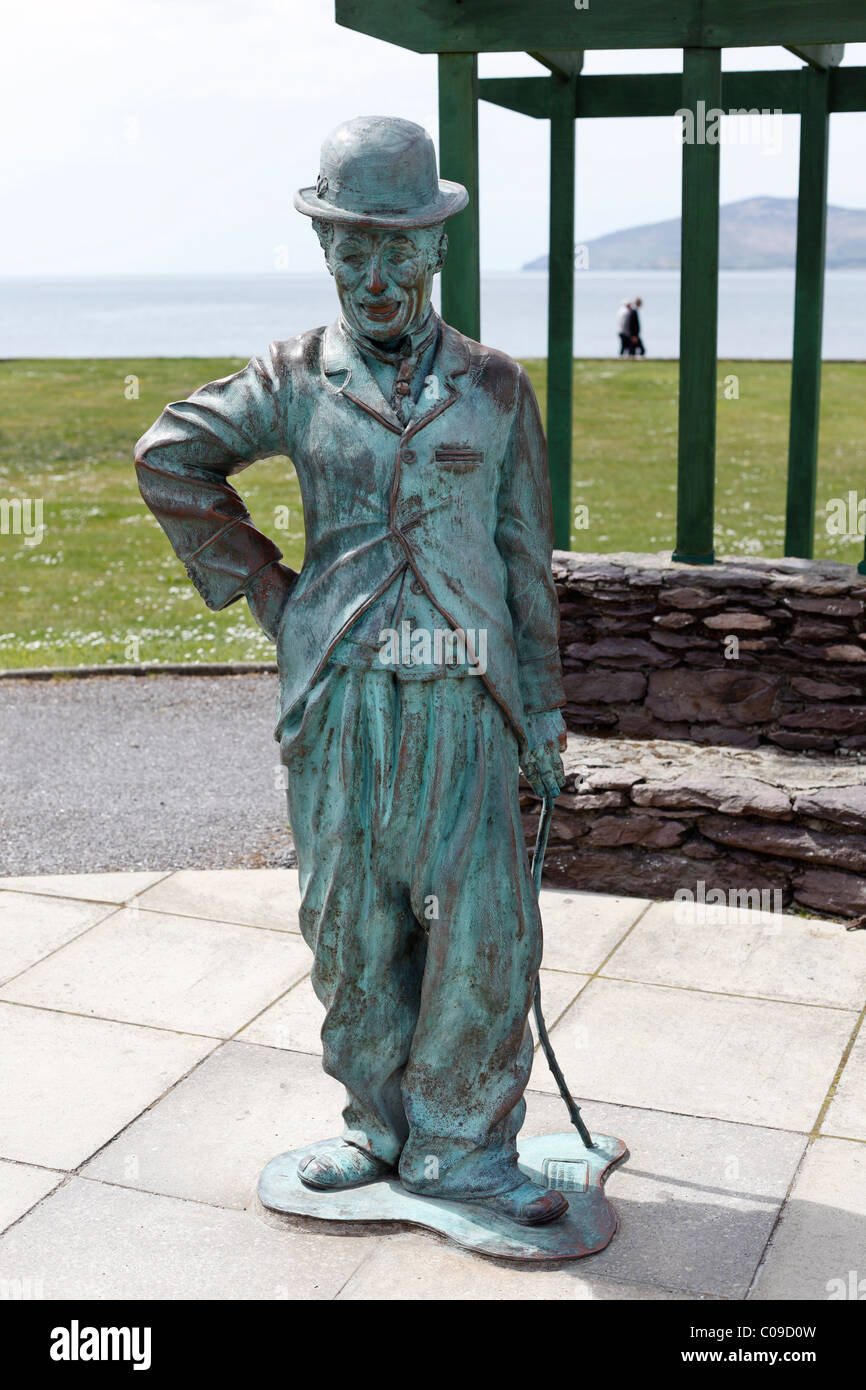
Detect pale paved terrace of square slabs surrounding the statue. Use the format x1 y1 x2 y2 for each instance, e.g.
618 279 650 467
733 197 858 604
0 870 866 1300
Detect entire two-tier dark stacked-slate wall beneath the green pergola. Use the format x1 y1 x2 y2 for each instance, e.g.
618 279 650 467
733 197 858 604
523 552 866 920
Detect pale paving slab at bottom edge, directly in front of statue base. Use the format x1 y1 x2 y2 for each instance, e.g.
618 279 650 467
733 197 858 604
336 1234 717 1302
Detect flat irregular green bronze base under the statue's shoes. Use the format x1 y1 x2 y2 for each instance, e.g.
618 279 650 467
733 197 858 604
257 1130 628 1261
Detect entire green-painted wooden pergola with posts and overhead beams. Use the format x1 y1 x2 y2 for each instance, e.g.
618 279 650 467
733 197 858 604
335 0 866 574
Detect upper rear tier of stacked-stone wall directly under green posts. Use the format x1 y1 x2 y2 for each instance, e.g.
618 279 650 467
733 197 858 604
553 552 866 753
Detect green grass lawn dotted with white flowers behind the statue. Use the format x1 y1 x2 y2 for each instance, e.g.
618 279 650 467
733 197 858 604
0 357 866 669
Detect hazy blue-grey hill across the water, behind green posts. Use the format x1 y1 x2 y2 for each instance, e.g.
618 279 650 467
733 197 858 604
521 197 866 270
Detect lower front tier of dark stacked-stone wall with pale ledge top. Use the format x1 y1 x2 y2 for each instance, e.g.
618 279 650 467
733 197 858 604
521 734 866 924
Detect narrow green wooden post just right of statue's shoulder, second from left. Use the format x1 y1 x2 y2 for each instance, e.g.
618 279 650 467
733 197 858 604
548 76 574 550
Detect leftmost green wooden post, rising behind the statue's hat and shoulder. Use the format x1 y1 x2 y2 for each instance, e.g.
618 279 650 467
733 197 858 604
439 53 481 339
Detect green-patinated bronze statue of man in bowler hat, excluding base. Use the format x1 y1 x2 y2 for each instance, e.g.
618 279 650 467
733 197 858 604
136 117 567 1225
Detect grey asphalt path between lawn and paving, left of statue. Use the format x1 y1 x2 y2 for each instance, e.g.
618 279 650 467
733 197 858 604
0 676 293 874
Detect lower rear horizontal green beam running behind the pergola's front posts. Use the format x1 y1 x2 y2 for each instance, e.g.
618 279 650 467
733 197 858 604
478 68 866 120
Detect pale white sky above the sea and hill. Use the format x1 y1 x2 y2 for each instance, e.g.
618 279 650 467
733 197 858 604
0 0 866 275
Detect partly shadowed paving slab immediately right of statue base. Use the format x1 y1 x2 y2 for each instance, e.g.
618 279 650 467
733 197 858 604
514 1091 806 1298
